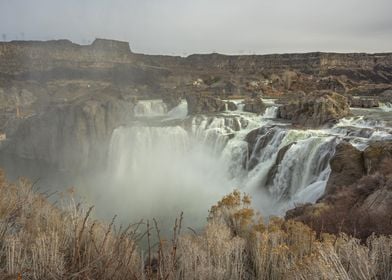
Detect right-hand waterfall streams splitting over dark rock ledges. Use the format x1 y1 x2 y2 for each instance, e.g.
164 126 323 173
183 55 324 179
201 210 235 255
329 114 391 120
244 127 337 214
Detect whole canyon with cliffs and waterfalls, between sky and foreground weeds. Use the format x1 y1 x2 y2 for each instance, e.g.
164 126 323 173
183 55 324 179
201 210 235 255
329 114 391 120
0 39 392 235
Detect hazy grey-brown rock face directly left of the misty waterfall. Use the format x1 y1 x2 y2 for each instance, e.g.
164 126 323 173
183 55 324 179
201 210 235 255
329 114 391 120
2 97 132 171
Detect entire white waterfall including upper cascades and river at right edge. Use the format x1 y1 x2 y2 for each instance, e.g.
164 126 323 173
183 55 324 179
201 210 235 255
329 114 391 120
74 97 392 229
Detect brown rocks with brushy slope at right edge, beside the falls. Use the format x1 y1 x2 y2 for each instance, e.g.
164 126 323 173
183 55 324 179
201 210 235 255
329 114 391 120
286 141 392 239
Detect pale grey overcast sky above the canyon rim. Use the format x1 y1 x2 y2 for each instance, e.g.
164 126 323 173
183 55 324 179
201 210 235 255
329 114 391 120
0 0 392 55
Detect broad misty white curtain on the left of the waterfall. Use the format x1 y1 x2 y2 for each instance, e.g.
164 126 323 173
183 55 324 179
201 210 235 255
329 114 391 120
101 125 234 226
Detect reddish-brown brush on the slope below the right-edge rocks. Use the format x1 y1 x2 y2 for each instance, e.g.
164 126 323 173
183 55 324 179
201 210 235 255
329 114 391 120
286 158 392 241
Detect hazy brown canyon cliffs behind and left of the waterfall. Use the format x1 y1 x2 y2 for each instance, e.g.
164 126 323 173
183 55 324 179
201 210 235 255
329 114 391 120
0 39 392 169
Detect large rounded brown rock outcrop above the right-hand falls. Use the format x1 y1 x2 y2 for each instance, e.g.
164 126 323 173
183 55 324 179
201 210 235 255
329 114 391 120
278 92 351 127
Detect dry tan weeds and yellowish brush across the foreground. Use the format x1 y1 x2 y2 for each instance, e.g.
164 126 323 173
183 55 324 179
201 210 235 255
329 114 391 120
0 172 392 280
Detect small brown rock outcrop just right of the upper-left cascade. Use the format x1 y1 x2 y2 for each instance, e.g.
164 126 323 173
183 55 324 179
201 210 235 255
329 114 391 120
186 93 226 115
